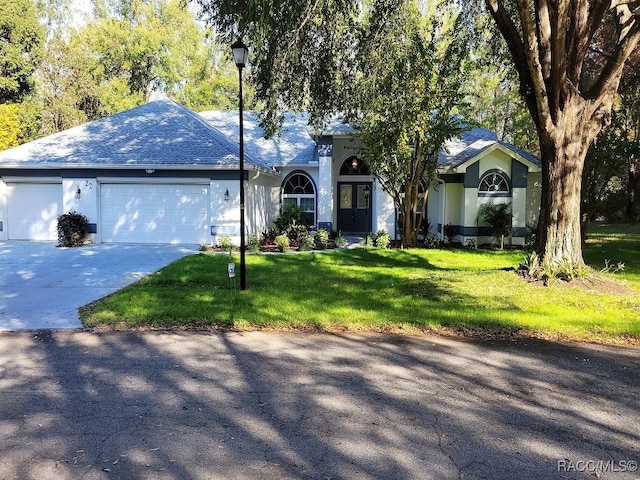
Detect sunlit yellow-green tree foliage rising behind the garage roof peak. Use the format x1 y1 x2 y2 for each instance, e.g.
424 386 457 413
29 0 238 135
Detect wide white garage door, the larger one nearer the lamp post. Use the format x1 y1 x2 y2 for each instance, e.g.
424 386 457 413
100 183 211 244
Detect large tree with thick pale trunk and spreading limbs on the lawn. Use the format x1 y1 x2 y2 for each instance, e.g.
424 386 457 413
485 0 640 266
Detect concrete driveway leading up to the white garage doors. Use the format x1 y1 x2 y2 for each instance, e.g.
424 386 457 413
0 241 198 331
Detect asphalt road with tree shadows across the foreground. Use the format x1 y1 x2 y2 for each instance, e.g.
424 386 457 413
0 330 640 480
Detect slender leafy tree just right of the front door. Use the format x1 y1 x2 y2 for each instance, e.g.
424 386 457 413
355 1 467 246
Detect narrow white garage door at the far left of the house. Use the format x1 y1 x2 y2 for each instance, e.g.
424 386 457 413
7 183 62 240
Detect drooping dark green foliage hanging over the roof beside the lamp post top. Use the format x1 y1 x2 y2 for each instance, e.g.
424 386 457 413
197 0 360 135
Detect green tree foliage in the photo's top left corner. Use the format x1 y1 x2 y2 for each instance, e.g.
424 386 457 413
0 0 44 104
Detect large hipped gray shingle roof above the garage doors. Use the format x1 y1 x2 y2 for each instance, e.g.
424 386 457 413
0 99 272 171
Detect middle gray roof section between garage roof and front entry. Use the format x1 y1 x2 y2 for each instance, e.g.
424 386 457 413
200 110 318 167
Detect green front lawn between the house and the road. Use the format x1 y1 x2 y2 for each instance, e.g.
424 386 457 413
80 226 640 343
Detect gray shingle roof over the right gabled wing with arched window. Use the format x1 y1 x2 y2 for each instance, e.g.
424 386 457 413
438 128 540 170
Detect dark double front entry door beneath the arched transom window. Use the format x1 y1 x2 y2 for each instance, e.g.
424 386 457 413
338 182 372 234
